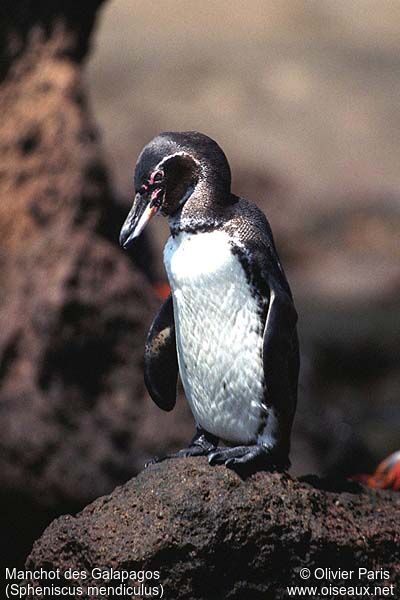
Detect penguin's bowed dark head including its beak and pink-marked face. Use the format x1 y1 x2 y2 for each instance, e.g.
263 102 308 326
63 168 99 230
120 131 231 249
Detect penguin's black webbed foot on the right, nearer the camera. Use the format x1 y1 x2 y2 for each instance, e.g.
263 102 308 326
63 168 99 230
208 445 288 471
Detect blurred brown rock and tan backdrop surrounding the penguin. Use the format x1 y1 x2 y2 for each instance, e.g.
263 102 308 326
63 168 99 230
0 0 400 566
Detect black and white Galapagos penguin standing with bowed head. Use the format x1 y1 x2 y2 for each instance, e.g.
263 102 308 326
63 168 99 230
120 131 299 470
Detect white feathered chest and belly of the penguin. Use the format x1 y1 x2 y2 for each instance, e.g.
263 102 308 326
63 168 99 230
164 231 266 443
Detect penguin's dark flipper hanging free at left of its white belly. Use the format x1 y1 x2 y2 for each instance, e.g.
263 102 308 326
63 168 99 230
144 295 178 411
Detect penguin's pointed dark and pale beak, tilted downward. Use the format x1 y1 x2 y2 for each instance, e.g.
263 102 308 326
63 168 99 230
119 188 163 250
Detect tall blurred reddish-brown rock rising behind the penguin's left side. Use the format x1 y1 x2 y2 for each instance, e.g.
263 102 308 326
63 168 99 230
0 1 190 562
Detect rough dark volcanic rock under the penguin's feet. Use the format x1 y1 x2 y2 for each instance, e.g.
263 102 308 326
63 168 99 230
26 459 400 600
